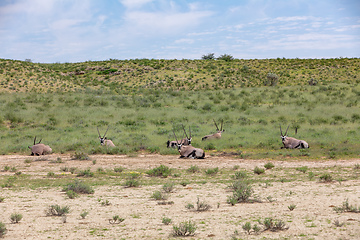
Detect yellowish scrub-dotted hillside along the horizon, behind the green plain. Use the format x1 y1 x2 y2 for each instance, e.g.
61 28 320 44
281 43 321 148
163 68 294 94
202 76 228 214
0 58 360 94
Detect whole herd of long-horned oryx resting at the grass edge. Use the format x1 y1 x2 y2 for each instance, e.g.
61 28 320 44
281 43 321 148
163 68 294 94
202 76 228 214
29 120 309 159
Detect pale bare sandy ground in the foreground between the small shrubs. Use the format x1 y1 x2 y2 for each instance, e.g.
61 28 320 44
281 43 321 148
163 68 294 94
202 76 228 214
0 154 360 239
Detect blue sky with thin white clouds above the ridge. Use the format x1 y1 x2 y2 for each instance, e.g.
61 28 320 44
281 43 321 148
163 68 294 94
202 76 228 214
0 0 360 63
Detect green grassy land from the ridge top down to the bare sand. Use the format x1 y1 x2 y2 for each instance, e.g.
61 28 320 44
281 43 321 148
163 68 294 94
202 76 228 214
0 58 360 159
